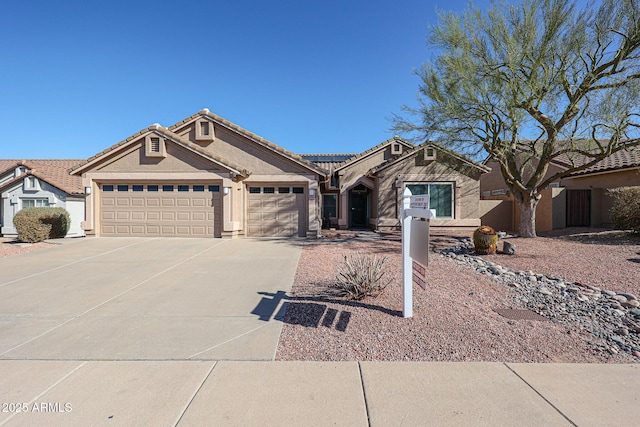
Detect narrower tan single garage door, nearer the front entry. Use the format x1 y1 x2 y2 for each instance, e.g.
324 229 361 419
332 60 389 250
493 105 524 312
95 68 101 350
247 186 306 237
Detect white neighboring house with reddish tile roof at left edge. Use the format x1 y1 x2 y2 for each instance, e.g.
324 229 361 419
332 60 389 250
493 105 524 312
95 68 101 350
0 160 85 237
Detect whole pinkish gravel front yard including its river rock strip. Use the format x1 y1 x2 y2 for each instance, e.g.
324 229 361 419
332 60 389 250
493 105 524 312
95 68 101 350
276 229 640 363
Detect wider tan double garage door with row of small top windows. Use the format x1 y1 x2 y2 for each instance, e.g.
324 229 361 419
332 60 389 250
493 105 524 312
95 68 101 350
99 183 222 237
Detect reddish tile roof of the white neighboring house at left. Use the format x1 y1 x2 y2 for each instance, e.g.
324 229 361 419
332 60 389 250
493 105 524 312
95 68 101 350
0 159 84 195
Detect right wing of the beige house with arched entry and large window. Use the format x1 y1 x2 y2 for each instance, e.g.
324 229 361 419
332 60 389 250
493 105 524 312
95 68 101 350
304 137 489 230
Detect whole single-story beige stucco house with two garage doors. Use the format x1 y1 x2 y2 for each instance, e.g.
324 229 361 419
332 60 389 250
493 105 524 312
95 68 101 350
71 109 489 238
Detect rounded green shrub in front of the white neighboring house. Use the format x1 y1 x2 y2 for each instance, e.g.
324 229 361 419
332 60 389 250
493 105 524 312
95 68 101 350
13 208 71 243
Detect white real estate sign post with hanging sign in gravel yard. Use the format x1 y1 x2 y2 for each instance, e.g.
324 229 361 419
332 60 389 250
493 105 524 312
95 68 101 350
402 188 435 317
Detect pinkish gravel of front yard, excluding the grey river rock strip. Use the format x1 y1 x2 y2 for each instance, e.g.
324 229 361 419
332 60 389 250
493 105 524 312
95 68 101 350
276 231 640 363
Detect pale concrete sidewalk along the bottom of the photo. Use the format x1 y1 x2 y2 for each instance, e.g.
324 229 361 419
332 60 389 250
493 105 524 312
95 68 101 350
0 360 640 426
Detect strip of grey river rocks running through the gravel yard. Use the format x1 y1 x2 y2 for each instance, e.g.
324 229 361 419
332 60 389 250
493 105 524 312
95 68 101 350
440 239 640 359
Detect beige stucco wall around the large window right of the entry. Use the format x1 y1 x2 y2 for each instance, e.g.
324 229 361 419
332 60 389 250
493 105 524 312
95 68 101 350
378 151 480 229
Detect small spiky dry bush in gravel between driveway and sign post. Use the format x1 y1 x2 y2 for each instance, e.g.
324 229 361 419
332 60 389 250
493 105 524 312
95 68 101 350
336 254 391 300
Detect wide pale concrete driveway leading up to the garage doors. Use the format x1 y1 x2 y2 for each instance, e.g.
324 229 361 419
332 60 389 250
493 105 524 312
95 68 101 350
0 238 300 360
